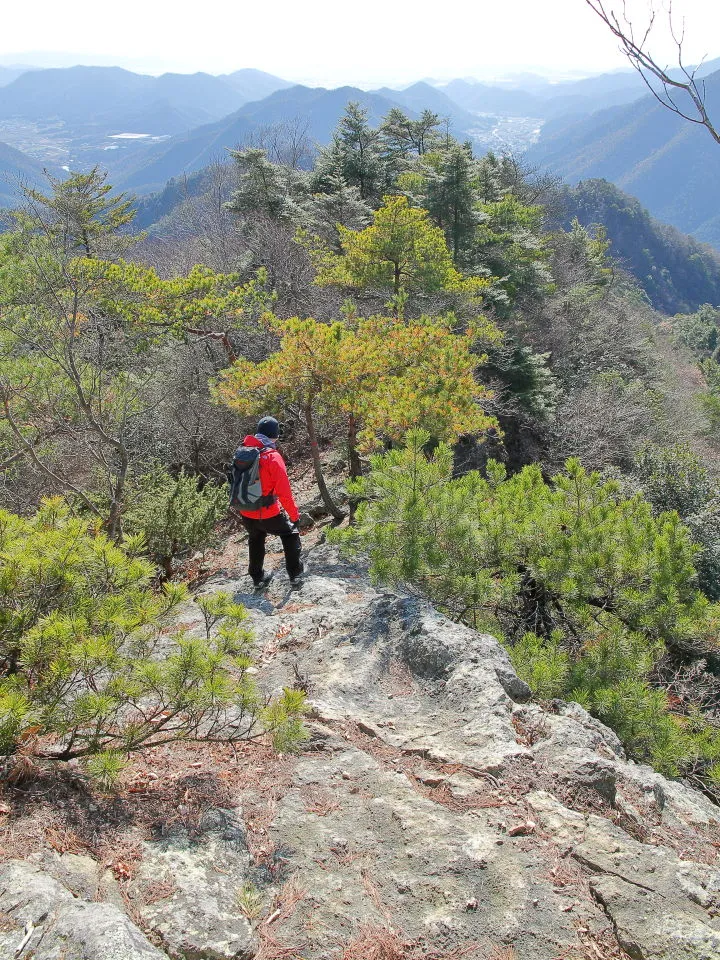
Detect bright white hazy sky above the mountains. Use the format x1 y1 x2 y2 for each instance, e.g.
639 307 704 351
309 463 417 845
0 0 720 85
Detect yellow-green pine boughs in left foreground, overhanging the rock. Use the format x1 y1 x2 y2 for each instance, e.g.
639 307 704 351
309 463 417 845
0 501 303 782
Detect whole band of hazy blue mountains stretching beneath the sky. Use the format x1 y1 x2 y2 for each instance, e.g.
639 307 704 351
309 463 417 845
5 59 718 228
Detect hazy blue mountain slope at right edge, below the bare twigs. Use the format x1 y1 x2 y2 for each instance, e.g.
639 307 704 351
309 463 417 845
527 71 720 247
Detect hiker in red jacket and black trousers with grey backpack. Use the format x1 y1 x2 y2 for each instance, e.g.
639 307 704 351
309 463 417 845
230 417 305 590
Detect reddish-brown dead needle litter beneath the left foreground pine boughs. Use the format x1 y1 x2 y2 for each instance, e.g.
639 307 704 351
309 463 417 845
0 743 294 879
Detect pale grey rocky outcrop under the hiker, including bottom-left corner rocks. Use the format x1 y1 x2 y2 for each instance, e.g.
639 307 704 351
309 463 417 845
0 546 720 960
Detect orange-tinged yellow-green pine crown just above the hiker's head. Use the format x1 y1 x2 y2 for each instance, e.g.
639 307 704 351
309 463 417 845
215 317 495 451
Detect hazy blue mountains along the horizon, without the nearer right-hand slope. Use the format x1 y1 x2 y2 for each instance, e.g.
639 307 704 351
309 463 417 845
0 66 660 196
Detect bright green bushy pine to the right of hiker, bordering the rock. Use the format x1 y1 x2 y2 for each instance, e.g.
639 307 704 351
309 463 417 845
335 431 720 779
